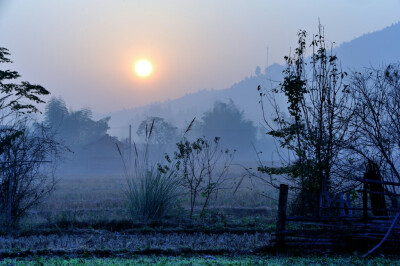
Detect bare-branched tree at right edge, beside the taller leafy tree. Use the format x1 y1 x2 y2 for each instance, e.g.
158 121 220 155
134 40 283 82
349 64 400 205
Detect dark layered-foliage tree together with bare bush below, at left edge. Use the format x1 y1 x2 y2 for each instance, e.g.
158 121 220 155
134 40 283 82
0 47 61 229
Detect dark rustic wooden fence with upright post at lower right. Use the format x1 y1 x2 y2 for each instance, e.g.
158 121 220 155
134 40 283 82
275 179 400 255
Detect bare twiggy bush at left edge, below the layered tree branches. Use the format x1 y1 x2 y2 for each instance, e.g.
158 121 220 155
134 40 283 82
0 121 65 225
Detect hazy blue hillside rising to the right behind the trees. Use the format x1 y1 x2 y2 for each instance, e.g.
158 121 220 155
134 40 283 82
104 23 400 140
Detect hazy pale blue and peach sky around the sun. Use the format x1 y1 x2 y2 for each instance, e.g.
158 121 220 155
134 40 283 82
0 0 400 113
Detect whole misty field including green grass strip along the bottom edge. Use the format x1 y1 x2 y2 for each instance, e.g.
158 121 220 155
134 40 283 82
0 167 395 265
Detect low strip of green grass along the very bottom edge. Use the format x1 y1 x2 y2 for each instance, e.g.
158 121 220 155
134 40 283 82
1 255 400 265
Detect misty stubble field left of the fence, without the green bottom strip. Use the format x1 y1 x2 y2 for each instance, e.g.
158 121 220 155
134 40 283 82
0 168 282 264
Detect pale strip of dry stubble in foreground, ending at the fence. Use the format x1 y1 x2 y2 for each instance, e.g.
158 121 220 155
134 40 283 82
0 230 270 252
